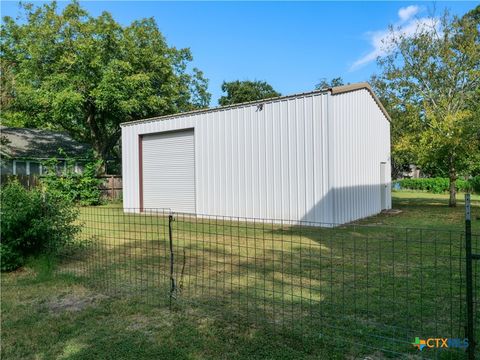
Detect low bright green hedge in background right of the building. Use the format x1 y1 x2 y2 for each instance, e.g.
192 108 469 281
396 176 480 194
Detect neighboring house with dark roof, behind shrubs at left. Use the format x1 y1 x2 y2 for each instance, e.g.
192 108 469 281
0 126 90 175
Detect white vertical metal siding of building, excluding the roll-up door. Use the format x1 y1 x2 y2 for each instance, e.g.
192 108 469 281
122 90 390 223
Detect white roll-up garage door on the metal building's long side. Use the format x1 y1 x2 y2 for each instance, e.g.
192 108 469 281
142 129 195 213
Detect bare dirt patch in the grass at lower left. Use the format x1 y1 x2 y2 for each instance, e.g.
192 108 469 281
43 292 107 314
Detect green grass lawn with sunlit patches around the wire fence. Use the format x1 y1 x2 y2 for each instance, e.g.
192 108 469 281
1 192 480 359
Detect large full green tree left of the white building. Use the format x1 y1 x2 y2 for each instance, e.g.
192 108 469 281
0 2 210 168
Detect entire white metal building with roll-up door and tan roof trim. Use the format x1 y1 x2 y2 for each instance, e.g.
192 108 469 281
122 83 391 223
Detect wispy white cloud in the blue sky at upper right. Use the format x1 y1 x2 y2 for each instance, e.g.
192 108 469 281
350 5 439 71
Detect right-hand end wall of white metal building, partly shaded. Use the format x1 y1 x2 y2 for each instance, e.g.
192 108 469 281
328 89 391 223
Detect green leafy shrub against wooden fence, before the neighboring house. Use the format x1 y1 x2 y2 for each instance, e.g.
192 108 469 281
42 150 102 205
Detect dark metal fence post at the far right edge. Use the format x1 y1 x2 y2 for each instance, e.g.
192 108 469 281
465 194 475 360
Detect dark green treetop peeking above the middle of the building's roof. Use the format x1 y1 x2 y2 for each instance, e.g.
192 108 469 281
218 80 281 106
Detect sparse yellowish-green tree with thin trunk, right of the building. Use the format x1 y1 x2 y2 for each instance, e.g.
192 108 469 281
376 8 480 206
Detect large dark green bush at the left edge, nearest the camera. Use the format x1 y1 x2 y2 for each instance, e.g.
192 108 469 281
0 181 79 271
